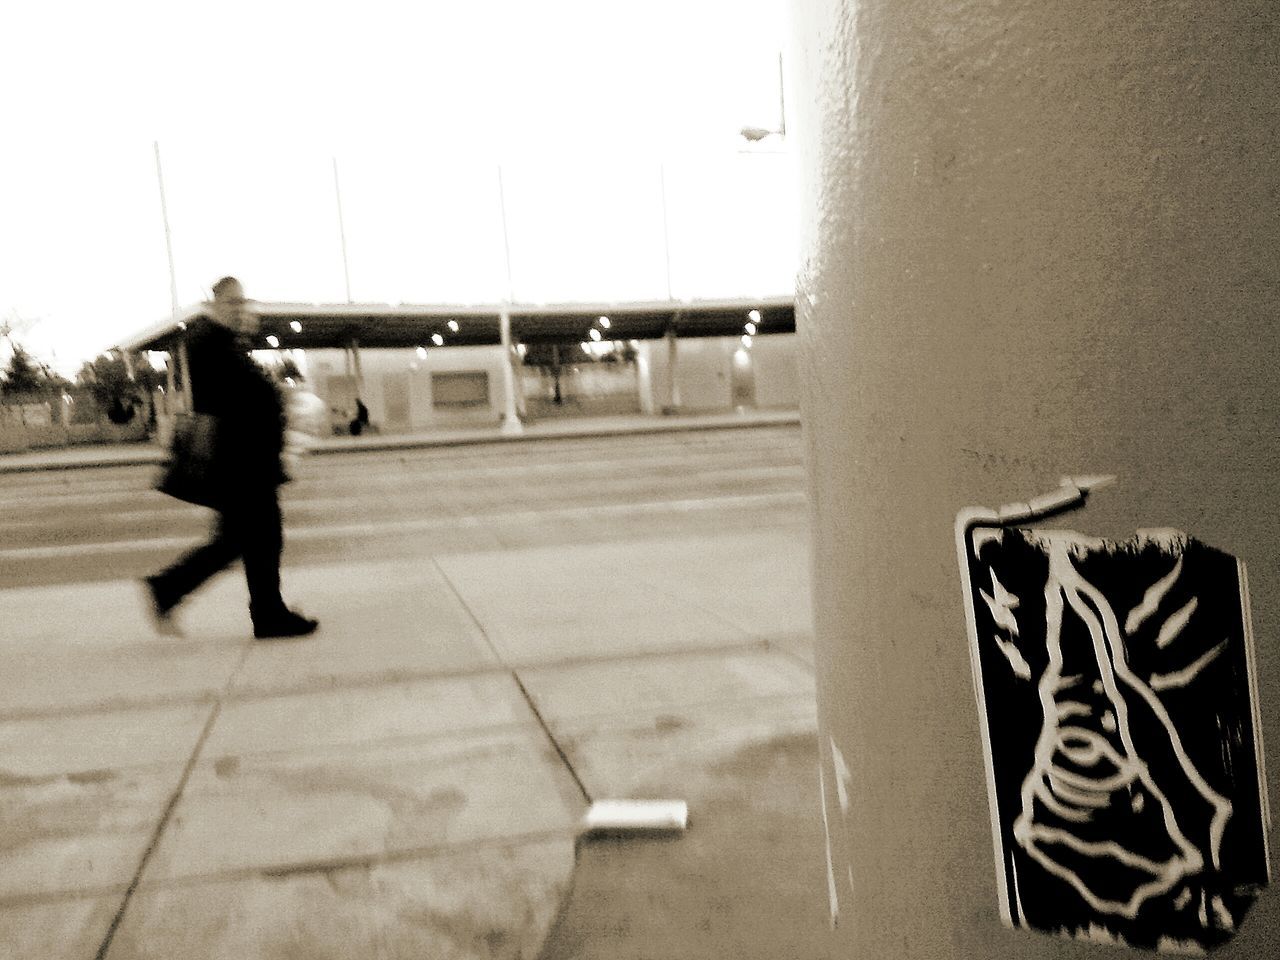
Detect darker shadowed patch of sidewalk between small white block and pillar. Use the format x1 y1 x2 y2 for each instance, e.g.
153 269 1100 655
538 735 838 960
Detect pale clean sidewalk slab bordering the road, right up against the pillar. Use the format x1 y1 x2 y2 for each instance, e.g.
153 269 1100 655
440 531 812 664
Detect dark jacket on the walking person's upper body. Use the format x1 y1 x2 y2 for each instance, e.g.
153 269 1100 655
187 320 288 497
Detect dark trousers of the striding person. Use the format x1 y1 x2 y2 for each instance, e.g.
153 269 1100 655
150 488 285 623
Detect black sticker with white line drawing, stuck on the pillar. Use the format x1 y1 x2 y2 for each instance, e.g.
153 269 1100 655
956 480 1270 952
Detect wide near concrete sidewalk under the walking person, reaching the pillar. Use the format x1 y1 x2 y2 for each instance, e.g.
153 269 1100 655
0 530 827 960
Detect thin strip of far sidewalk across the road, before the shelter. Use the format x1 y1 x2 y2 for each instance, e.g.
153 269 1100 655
0 410 800 474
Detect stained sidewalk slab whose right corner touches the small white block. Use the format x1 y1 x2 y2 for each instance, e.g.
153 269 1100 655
143 723 582 882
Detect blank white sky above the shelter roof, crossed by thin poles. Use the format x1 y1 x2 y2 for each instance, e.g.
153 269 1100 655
0 0 795 374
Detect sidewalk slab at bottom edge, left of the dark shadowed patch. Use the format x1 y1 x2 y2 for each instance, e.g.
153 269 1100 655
102 837 573 960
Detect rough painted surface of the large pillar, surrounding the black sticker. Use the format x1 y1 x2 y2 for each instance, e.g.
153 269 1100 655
788 0 1280 960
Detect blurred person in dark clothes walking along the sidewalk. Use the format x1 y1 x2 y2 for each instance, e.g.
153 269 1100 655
145 276 319 640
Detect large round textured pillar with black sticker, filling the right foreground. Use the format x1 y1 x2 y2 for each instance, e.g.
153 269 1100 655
788 0 1280 960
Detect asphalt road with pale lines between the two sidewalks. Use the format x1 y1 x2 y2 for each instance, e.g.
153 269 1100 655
0 425 808 589
